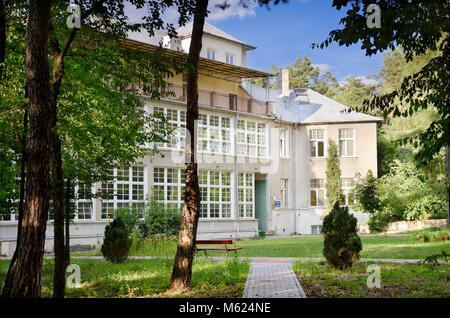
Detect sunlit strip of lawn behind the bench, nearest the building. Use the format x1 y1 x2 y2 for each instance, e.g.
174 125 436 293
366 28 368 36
72 235 450 259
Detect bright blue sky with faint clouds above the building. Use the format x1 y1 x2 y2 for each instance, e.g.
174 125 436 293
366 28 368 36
208 0 383 81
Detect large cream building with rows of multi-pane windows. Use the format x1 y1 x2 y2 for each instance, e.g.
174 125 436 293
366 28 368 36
0 23 379 254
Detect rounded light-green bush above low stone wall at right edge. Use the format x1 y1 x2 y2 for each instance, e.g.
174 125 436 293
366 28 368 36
405 195 447 221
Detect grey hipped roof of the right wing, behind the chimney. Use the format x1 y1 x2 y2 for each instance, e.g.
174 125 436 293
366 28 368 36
242 81 381 124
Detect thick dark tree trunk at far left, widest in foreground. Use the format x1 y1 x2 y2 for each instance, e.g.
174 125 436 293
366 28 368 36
2 0 51 298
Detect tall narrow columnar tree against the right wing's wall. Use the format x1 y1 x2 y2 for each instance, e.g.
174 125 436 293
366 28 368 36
326 139 343 211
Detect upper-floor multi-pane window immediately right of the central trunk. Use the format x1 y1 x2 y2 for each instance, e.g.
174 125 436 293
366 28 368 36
197 114 232 154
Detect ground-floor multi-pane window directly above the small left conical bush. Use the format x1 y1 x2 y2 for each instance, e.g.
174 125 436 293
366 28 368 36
100 166 146 219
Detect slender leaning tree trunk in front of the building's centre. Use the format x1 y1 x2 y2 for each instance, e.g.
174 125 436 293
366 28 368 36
170 0 208 293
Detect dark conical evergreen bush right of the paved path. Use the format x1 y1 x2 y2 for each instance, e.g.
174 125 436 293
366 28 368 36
322 203 362 269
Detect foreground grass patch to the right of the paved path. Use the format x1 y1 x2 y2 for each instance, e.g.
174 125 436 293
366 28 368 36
293 262 450 298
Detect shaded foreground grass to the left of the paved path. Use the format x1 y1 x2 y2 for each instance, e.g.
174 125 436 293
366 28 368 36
0 259 249 298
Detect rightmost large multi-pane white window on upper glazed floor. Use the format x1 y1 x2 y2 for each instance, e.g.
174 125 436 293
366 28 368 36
237 120 267 158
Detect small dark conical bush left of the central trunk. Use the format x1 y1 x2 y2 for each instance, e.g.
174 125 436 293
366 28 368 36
101 217 131 263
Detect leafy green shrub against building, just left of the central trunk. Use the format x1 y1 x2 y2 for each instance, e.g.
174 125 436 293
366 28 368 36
139 196 181 237
